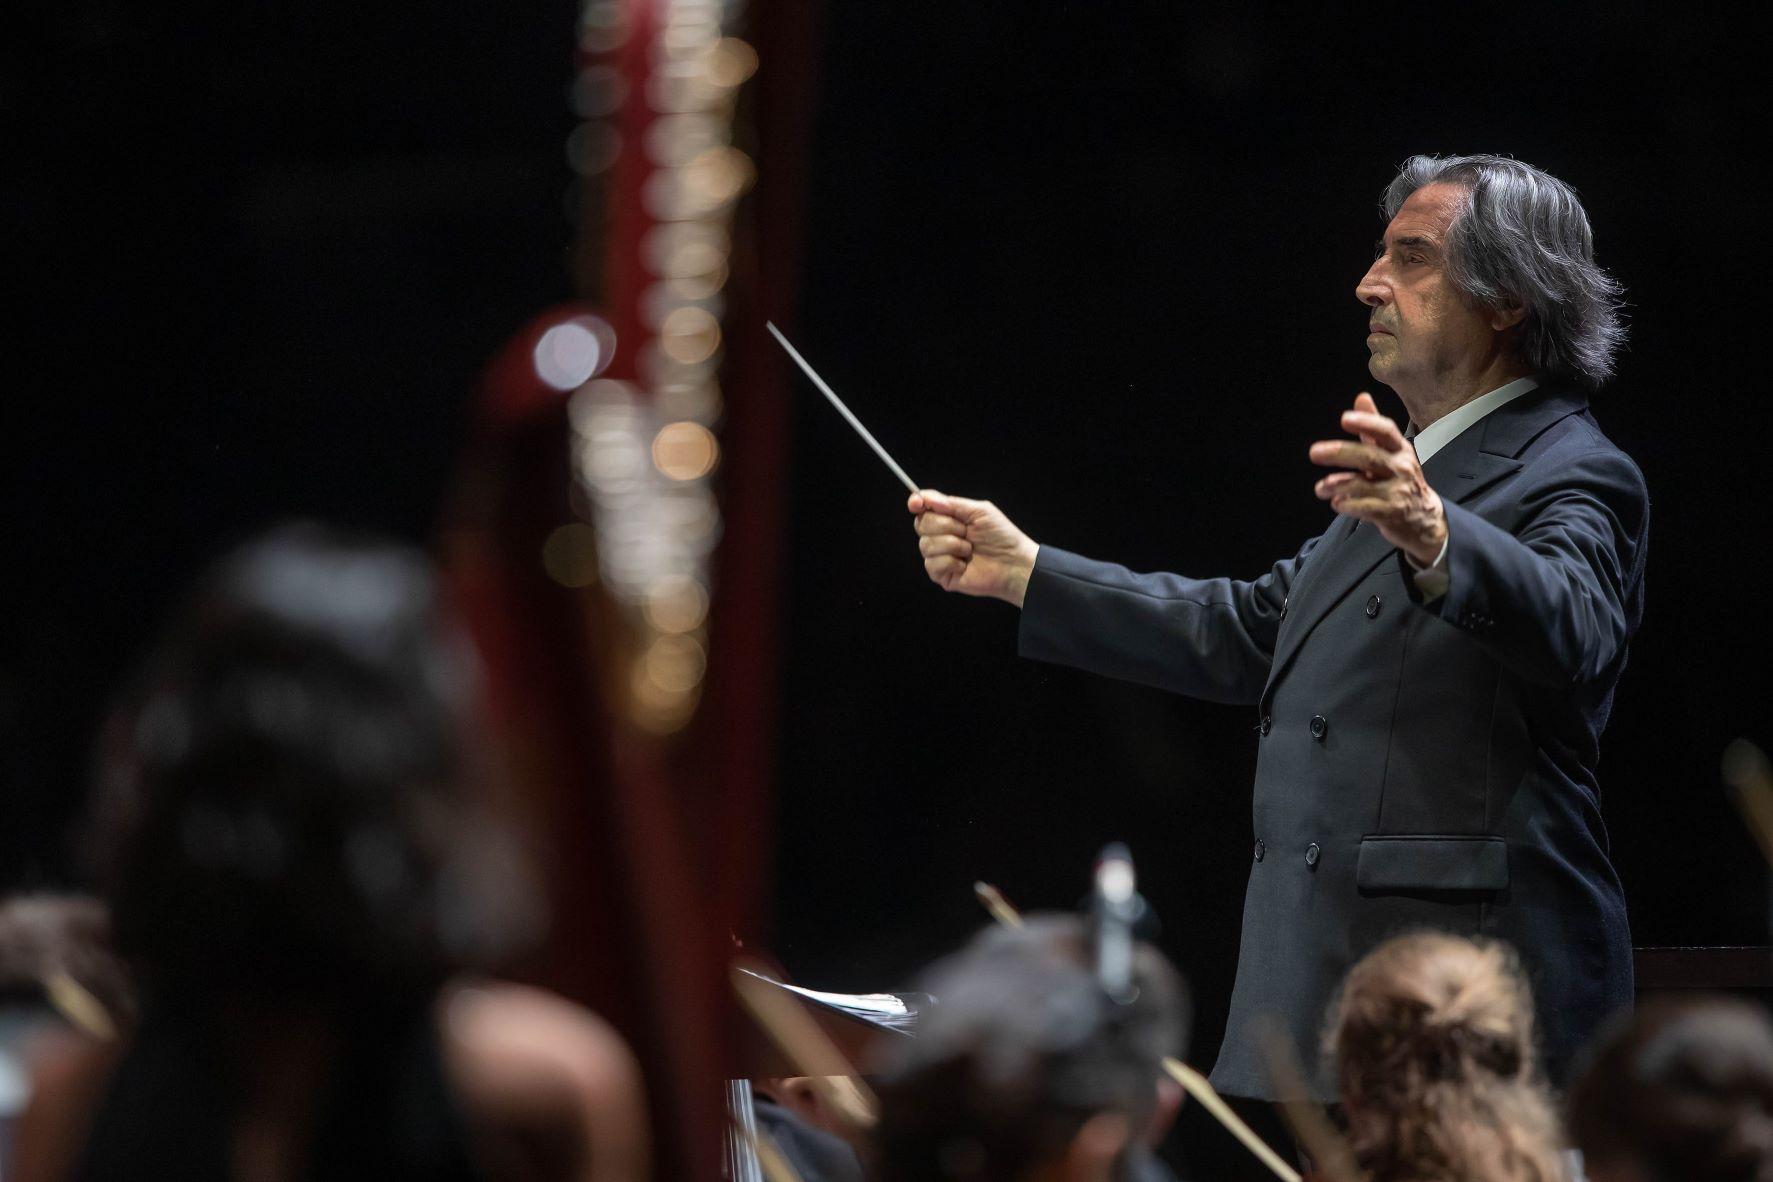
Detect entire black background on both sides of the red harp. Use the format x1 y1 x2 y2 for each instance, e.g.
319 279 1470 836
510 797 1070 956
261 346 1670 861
0 0 1773 1176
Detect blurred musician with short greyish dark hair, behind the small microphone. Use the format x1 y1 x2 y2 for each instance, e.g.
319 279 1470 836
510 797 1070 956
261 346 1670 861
869 916 1188 1182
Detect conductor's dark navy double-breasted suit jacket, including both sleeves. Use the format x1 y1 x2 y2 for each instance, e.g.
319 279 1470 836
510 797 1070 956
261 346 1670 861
1019 388 1649 1099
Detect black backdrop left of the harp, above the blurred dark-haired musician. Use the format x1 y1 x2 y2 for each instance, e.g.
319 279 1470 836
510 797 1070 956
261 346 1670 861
0 0 576 888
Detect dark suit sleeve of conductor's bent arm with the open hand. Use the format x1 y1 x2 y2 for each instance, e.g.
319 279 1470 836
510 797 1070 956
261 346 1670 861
1424 443 1649 686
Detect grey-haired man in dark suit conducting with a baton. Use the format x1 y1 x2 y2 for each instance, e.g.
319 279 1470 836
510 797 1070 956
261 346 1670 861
908 156 1649 1099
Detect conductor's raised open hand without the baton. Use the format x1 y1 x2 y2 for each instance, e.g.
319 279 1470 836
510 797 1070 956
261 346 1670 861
1312 393 1447 567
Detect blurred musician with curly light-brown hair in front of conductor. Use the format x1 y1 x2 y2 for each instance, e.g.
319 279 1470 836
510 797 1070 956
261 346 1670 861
1328 932 1567 1182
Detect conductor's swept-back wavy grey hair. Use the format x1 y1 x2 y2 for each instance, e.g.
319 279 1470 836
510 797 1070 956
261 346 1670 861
1381 156 1626 386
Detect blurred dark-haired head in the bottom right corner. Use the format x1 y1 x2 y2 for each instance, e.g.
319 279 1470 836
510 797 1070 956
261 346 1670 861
1569 998 1773 1182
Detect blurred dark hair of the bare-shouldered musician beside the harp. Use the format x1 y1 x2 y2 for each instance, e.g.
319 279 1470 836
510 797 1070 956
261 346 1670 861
92 523 535 998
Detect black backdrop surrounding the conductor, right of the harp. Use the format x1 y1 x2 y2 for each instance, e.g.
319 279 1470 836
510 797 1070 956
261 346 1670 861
778 4 1773 1098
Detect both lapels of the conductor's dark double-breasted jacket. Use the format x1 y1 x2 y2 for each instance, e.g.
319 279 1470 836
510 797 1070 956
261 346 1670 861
1262 390 1589 702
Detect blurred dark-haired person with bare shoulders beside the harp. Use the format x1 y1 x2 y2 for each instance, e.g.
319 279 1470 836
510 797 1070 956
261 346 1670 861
16 526 647 1182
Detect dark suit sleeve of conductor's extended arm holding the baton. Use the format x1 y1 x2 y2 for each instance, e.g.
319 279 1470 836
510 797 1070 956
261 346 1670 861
1018 539 1319 705
